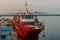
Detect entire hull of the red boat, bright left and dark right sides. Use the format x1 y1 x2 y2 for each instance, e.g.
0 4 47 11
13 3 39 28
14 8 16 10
14 23 44 37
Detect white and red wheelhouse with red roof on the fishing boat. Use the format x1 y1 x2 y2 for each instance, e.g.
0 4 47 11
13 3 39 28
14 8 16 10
19 14 37 25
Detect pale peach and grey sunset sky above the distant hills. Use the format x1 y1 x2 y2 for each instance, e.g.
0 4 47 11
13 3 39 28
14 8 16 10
0 0 60 14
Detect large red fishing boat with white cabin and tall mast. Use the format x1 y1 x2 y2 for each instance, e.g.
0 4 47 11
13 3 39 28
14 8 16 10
13 0 45 40
